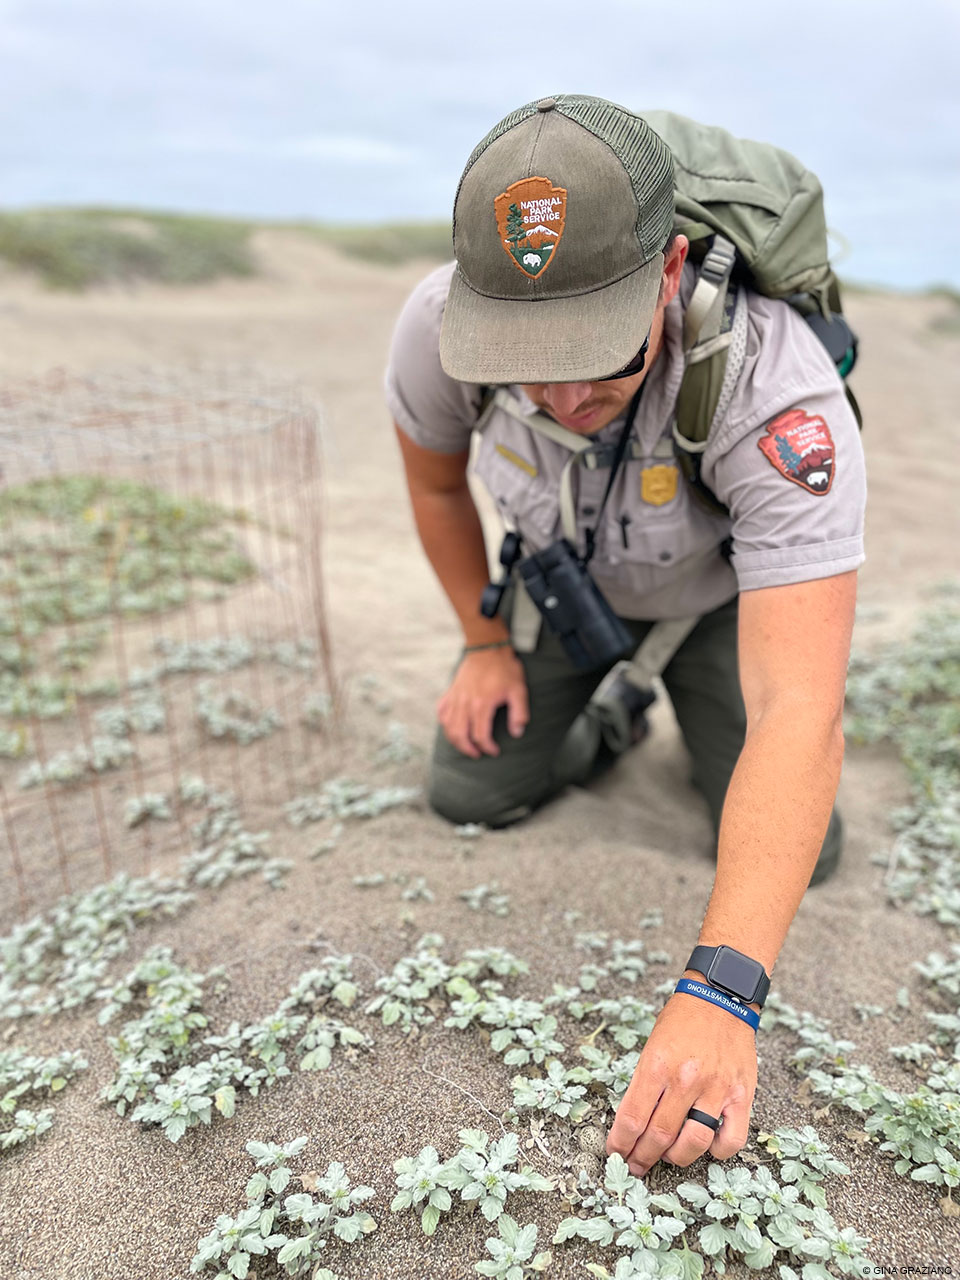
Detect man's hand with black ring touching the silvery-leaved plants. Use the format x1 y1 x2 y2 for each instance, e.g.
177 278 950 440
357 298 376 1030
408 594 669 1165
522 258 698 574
607 974 756 1176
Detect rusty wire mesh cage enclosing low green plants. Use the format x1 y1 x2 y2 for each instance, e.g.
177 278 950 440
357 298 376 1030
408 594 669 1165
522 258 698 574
0 369 337 915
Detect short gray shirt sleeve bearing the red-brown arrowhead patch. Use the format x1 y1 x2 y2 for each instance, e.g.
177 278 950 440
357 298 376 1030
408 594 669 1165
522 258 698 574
701 294 867 591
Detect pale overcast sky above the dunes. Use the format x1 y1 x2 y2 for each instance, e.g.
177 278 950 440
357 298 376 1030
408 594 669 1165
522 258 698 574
0 0 960 287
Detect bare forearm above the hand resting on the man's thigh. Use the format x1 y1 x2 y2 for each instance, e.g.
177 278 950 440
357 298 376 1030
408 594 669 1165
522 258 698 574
411 484 509 644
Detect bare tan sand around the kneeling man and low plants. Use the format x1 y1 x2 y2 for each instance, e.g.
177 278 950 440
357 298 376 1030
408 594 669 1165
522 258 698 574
0 232 960 1280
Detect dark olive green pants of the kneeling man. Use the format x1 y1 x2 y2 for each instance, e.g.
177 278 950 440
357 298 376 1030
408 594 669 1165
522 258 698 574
429 598 842 883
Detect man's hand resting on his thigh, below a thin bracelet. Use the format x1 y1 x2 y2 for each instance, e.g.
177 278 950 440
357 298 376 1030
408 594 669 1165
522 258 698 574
436 648 530 759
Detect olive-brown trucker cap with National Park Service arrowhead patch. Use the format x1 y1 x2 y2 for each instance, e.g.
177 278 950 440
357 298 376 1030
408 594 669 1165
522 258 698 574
440 93 673 383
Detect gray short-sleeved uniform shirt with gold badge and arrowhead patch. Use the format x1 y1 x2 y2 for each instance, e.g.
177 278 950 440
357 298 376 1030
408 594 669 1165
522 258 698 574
385 264 867 620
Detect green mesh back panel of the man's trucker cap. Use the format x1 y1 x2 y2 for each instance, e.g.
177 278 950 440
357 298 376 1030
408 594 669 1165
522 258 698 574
453 93 673 257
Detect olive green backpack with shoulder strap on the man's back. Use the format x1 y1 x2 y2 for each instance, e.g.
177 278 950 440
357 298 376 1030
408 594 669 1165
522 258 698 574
640 111 861 512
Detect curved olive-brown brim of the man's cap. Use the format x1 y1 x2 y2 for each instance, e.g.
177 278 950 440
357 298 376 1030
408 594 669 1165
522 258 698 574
440 253 663 383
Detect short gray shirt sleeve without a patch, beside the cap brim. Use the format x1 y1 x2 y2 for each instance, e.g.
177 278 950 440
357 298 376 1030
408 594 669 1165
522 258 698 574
384 262 483 453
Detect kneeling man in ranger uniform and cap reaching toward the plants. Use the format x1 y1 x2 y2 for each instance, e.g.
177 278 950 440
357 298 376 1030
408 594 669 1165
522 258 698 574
387 96 865 1172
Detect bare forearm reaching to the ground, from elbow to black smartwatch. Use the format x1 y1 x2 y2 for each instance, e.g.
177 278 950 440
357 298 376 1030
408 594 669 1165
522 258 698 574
689 701 844 977
